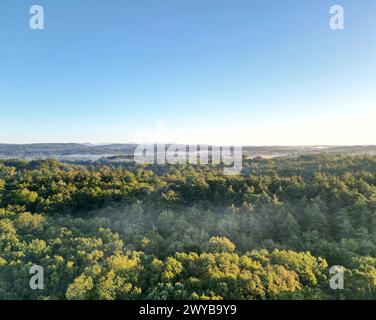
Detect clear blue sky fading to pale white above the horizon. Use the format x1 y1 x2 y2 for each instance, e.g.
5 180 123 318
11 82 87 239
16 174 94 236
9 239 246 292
0 0 376 145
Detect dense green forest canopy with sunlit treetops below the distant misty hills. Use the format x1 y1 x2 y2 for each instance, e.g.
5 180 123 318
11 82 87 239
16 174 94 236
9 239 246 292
0 155 376 299
